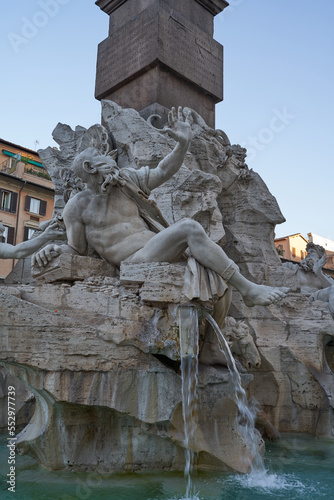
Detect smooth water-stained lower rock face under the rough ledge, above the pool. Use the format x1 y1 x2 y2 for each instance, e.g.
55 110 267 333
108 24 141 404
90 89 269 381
1 364 248 472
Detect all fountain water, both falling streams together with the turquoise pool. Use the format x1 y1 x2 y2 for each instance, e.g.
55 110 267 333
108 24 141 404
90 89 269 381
0 306 334 500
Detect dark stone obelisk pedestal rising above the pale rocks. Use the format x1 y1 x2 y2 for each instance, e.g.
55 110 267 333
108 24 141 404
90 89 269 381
95 0 228 127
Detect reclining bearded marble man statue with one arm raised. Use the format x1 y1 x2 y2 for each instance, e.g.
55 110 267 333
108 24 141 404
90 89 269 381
34 107 288 306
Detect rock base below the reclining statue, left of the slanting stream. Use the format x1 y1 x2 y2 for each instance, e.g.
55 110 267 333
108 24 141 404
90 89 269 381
0 277 256 471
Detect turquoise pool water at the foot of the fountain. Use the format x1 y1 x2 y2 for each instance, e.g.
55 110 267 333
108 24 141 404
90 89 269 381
0 434 334 500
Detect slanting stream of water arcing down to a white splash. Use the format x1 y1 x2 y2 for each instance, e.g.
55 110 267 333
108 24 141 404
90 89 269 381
202 310 267 474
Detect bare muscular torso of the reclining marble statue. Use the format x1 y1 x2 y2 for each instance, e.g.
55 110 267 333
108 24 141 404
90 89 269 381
64 186 155 266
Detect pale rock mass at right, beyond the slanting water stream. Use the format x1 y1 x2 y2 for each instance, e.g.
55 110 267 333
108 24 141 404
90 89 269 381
230 292 334 437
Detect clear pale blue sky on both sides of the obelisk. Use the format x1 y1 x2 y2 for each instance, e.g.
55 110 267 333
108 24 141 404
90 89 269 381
0 0 334 240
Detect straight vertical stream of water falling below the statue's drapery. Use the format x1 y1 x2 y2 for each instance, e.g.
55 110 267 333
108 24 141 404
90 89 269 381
178 305 198 500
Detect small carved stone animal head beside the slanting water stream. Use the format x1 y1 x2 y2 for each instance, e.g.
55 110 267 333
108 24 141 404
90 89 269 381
224 318 261 369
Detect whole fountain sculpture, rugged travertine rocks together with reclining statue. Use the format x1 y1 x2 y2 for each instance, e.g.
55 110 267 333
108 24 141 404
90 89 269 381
0 101 334 473
